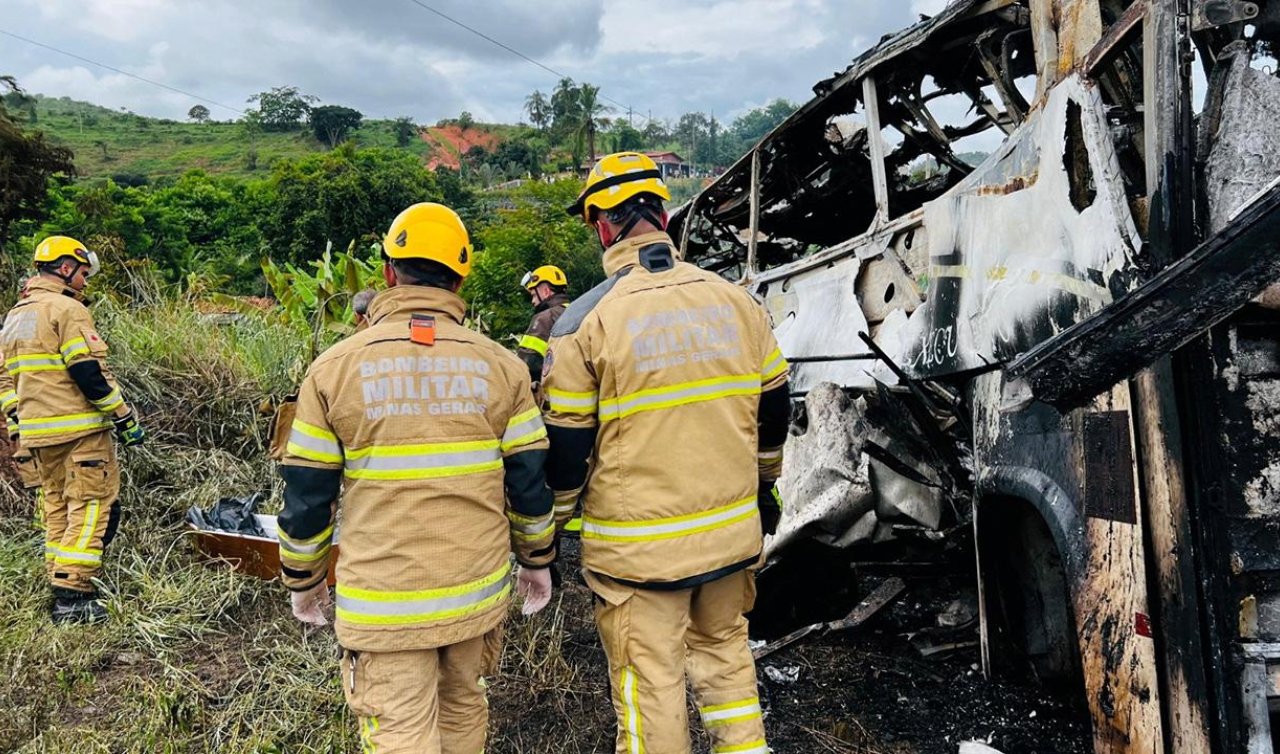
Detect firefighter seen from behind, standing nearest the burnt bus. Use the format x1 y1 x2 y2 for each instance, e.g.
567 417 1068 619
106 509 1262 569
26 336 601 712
543 152 790 754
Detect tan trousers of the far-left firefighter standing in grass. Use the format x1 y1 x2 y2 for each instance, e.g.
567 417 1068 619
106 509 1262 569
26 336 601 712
32 431 120 591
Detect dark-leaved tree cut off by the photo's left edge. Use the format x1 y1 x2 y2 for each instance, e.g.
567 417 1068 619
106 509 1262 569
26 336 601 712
0 76 76 246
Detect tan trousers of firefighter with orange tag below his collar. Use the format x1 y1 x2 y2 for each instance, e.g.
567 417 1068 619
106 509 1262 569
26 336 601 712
342 626 502 754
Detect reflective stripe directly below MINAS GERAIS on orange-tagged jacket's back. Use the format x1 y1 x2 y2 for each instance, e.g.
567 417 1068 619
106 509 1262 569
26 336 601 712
346 440 502 480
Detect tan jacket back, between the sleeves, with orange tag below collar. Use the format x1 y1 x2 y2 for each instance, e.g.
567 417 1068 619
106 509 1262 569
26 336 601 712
300 289 525 649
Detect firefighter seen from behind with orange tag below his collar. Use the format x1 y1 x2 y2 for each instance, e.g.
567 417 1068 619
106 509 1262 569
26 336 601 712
279 204 556 754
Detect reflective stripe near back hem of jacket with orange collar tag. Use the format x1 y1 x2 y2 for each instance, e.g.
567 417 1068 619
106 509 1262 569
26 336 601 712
337 563 511 626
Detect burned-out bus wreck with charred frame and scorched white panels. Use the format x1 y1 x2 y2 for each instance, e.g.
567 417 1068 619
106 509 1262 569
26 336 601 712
673 0 1280 753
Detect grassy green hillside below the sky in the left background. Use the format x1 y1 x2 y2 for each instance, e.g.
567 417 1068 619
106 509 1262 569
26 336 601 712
28 97 460 179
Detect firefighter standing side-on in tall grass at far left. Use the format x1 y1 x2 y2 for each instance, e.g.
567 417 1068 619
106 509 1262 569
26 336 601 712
0 236 143 623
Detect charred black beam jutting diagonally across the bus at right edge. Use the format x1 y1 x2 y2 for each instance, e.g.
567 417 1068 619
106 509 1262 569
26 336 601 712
1006 184 1280 408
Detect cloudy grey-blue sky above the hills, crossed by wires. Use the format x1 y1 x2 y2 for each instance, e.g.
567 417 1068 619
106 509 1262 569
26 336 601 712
0 0 946 125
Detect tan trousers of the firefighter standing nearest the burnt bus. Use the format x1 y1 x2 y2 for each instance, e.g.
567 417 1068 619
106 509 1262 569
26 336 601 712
586 570 769 754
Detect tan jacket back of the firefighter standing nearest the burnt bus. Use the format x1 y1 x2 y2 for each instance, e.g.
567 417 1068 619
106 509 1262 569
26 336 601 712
549 244 772 582
